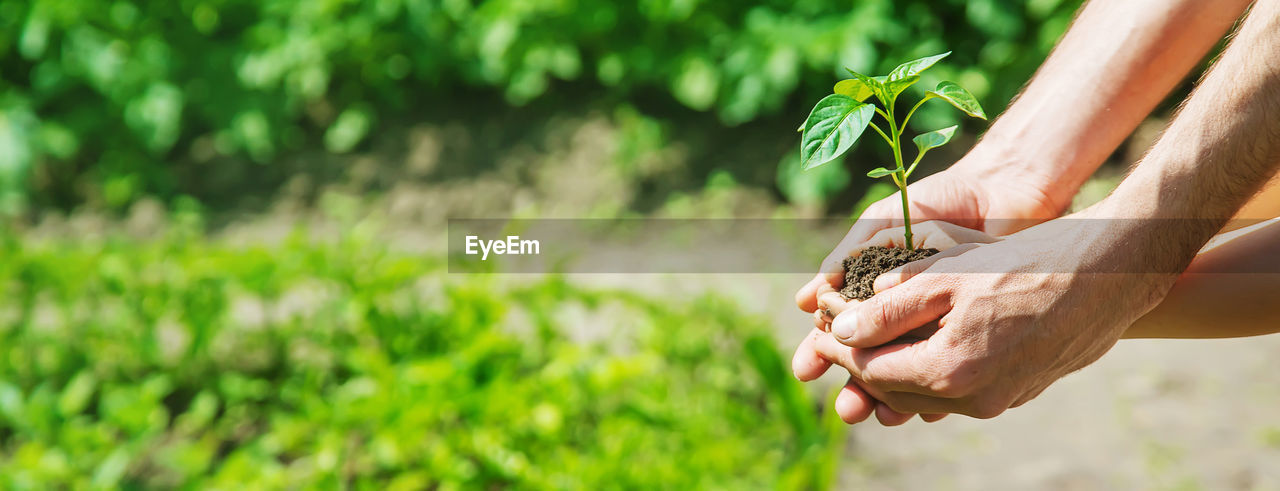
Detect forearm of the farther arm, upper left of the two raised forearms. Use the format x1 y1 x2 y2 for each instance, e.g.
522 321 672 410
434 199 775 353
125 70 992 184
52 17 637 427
957 0 1248 211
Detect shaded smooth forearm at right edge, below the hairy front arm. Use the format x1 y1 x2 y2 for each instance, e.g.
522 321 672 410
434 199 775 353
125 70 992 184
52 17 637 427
1124 220 1280 338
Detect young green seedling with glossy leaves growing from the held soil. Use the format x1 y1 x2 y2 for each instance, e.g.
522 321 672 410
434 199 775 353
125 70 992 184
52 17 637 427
800 51 987 249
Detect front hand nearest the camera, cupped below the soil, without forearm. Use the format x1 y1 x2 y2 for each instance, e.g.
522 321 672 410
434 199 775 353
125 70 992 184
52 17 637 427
806 220 1178 418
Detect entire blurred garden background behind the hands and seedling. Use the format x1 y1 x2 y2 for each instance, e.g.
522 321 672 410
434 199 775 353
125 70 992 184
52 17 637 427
0 0 1280 490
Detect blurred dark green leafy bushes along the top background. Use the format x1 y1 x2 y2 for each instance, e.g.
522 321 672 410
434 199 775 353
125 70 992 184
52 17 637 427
0 0 1079 211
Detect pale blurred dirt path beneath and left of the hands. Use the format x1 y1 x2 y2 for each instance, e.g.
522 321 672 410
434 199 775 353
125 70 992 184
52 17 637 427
575 275 1280 490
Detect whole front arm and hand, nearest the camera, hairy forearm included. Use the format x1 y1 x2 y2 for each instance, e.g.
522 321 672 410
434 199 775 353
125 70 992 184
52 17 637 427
814 0 1280 418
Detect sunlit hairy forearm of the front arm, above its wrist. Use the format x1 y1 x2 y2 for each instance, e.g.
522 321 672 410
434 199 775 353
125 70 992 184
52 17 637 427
1082 0 1280 301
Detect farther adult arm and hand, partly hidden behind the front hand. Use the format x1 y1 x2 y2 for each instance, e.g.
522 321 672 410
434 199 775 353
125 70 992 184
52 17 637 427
792 0 1248 423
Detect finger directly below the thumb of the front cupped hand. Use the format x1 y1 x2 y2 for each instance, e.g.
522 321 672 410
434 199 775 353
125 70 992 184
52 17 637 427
806 335 932 399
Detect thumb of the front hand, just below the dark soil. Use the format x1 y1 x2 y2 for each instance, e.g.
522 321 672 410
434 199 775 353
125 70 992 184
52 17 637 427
831 280 951 348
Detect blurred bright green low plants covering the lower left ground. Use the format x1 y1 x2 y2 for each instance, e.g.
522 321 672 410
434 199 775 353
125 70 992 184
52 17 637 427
0 226 842 490
